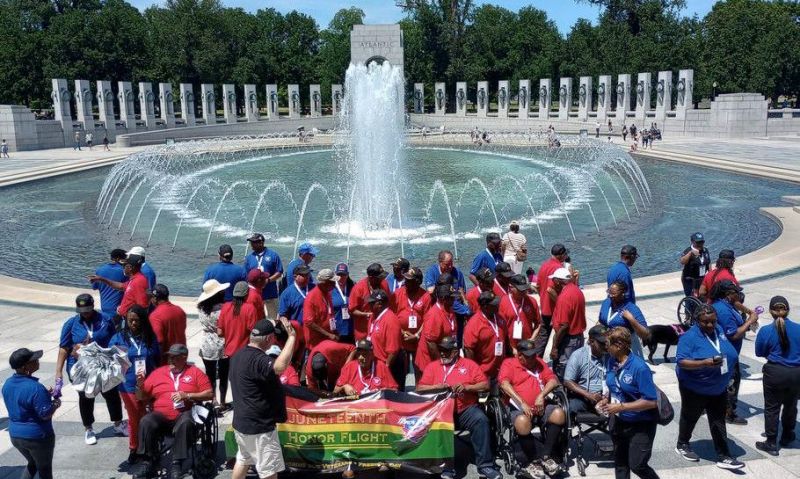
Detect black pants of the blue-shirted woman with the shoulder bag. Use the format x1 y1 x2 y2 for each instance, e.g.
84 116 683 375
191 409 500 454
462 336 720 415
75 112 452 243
612 419 659 479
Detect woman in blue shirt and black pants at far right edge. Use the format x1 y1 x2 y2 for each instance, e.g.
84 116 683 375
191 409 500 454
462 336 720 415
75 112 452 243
756 296 800 456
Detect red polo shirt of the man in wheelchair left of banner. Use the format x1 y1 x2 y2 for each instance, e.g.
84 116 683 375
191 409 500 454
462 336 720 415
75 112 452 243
142 364 211 420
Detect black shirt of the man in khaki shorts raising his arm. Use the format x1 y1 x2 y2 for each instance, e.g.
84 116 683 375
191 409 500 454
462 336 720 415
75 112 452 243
230 345 286 434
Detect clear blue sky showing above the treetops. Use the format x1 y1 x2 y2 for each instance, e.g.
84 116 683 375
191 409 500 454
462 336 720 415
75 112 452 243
129 0 716 33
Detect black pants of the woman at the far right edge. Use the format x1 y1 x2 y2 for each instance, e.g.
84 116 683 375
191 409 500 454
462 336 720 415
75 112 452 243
761 363 800 442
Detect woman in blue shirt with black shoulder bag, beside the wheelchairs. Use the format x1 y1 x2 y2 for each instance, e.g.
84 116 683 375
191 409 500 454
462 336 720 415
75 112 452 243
597 327 658 479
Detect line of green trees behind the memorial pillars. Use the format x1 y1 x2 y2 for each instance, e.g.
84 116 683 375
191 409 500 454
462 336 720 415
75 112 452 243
0 0 800 108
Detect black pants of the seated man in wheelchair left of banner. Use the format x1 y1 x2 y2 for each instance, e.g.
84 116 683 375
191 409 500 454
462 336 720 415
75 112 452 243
136 409 194 462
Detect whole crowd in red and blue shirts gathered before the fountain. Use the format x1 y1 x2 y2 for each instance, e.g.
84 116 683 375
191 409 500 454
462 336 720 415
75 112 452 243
3 228 800 479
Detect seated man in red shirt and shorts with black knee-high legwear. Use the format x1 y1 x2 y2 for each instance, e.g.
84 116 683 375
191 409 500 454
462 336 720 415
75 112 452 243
497 339 567 477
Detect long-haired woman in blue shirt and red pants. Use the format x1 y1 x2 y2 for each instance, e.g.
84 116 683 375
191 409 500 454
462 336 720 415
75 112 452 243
109 305 161 464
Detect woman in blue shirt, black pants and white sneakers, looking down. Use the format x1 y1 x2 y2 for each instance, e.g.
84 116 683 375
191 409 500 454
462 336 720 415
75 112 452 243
675 304 744 469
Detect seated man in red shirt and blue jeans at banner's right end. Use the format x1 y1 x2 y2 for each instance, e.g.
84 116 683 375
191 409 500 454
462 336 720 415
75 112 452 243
417 336 502 479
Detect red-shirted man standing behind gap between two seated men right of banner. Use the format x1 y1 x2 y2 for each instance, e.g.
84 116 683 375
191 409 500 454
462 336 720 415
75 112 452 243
464 291 508 380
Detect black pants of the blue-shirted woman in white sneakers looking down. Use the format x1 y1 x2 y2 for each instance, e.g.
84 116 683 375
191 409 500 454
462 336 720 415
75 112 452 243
678 386 731 456
